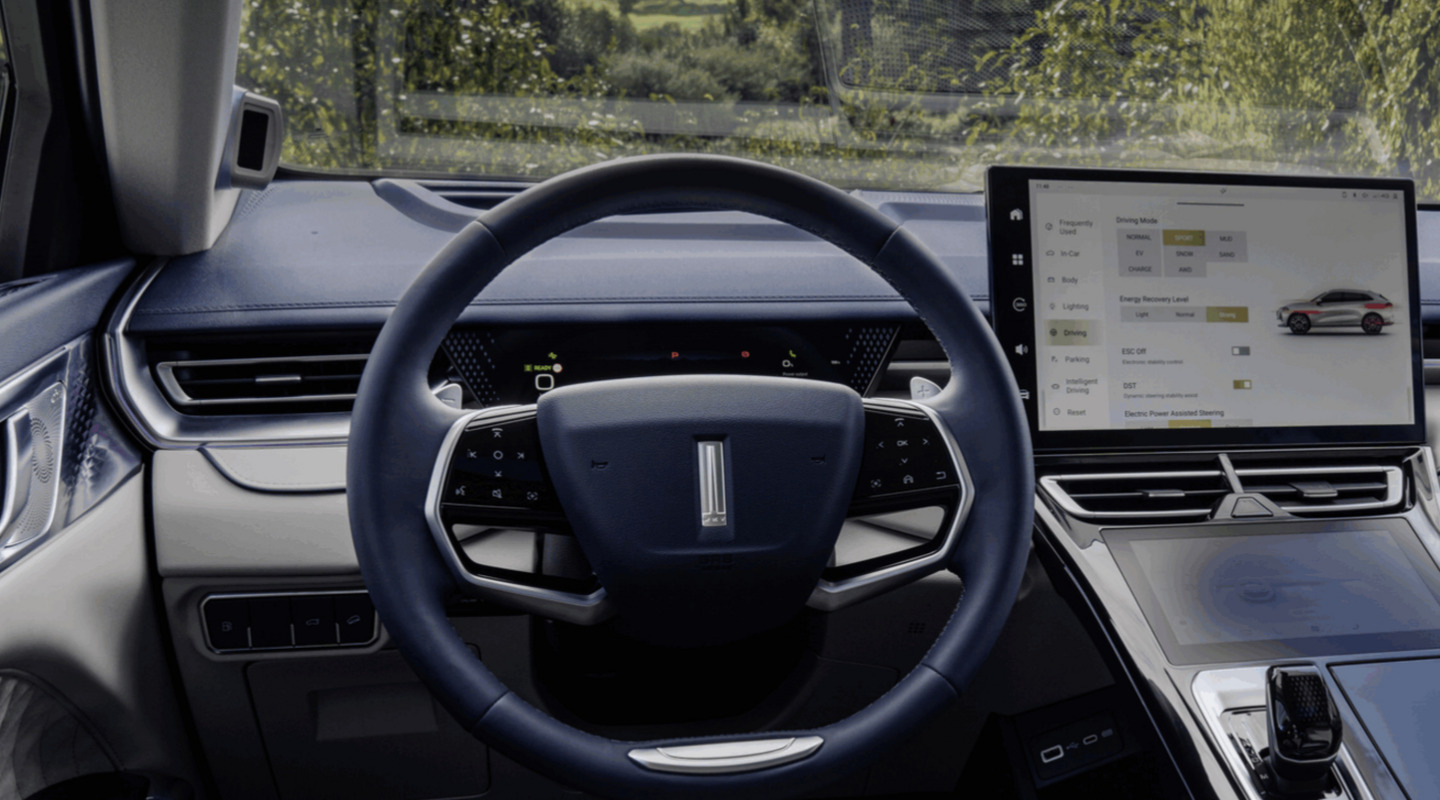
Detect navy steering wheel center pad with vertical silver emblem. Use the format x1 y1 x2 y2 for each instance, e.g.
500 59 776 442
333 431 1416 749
536 376 865 646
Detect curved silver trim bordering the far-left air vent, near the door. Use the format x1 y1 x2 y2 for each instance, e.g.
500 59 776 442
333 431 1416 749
99 259 350 449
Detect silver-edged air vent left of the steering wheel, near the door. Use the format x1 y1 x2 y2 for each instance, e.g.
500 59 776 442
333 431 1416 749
156 353 367 413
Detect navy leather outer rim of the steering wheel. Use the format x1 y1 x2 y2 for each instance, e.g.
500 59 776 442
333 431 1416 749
347 155 1034 797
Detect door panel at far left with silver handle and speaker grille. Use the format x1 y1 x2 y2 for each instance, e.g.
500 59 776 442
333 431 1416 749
0 263 197 800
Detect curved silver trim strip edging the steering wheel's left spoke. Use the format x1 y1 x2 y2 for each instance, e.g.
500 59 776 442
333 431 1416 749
425 404 615 624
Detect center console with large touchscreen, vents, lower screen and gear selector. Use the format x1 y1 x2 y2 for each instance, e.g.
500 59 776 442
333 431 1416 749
986 167 1440 800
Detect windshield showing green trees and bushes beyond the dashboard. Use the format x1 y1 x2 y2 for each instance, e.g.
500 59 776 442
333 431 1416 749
236 0 1440 201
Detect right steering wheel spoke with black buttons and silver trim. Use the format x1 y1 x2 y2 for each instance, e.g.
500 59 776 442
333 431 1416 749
808 399 973 612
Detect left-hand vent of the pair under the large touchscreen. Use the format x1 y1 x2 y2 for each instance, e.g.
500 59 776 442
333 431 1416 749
1040 469 1230 522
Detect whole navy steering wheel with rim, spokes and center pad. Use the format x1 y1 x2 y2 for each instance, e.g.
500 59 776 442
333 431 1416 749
347 155 1034 797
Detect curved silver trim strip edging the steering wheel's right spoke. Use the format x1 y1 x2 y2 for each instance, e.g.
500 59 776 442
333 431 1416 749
805 397 975 612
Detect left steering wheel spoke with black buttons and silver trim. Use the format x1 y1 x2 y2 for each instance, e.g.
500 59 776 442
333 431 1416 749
426 406 613 624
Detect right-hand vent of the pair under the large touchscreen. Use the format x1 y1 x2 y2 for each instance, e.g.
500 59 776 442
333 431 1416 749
1236 463 1405 517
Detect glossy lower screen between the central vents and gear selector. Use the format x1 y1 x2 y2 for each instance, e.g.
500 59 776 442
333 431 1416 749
1104 519 1440 663
